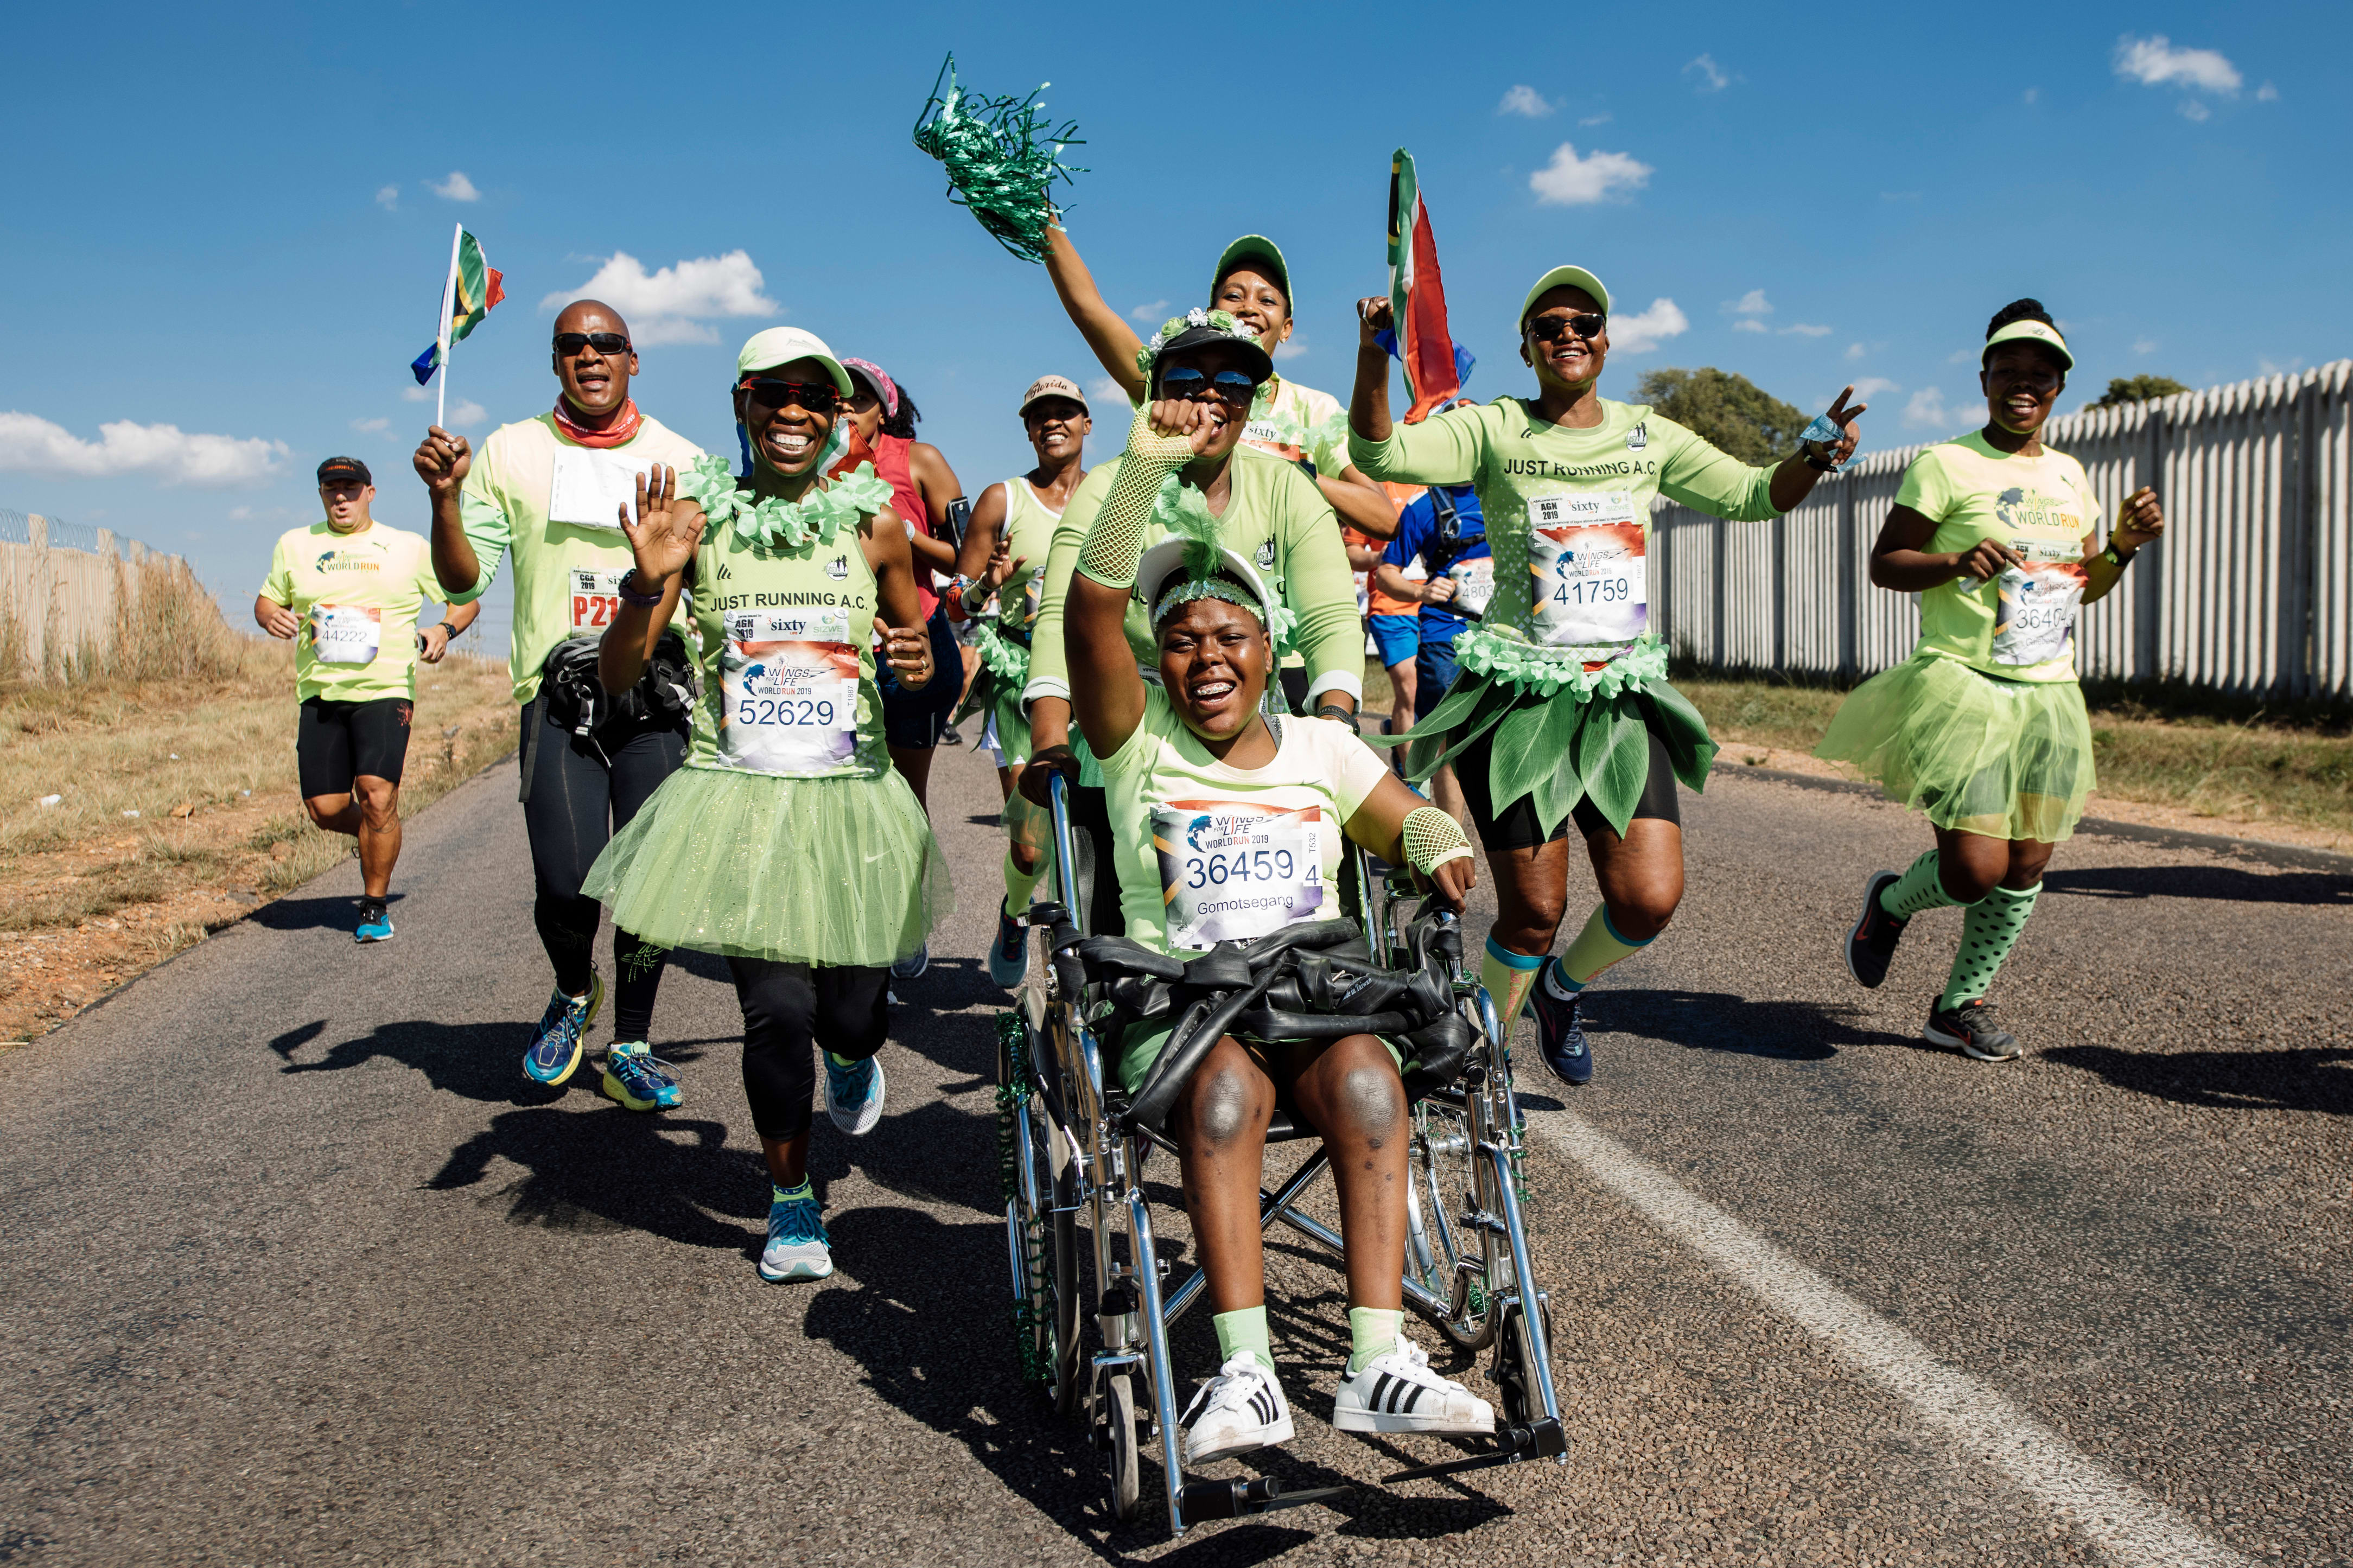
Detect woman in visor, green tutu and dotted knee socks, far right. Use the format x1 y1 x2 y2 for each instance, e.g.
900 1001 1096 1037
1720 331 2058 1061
1814 298 2165 1062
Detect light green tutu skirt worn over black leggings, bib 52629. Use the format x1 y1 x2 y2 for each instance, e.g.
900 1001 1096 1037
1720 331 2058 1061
581 764 955 968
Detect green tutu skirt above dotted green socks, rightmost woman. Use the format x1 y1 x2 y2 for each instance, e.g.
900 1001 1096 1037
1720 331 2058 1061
1814 654 2094 844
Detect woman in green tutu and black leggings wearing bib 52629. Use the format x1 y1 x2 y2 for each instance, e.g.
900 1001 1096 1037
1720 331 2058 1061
586 327 953 1281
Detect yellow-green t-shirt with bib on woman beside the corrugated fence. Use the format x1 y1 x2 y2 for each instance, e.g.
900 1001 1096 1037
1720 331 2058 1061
1897 432 2099 682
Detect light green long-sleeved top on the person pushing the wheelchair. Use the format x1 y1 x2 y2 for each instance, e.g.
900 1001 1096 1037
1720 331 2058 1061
1021 447 1365 703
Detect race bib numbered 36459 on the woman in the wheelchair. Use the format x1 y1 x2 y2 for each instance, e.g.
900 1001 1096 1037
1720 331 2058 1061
1153 799 1325 952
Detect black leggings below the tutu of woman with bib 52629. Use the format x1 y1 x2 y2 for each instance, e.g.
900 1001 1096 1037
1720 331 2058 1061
727 959 889 1140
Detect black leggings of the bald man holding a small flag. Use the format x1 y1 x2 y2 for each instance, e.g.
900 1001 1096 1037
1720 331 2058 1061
523 698 687 1039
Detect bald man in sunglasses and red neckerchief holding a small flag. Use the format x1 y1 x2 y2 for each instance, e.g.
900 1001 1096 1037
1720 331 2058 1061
416 298 703 1110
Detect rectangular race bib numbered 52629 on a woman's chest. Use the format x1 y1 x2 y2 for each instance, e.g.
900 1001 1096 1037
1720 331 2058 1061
720 609 859 778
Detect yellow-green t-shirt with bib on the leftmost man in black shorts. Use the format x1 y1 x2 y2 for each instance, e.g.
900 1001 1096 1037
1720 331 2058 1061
261 520 449 703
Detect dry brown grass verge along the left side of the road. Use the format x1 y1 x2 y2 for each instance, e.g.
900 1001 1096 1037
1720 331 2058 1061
0 639 516 1041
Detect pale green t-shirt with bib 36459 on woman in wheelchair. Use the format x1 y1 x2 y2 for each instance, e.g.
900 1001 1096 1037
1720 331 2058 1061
1101 686 1388 952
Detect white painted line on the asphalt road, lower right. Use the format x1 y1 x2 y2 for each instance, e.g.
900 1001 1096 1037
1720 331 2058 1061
1527 1112 2252 1568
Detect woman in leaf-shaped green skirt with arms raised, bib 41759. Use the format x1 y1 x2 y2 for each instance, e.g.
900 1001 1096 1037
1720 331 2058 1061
1349 266 1864 1083
